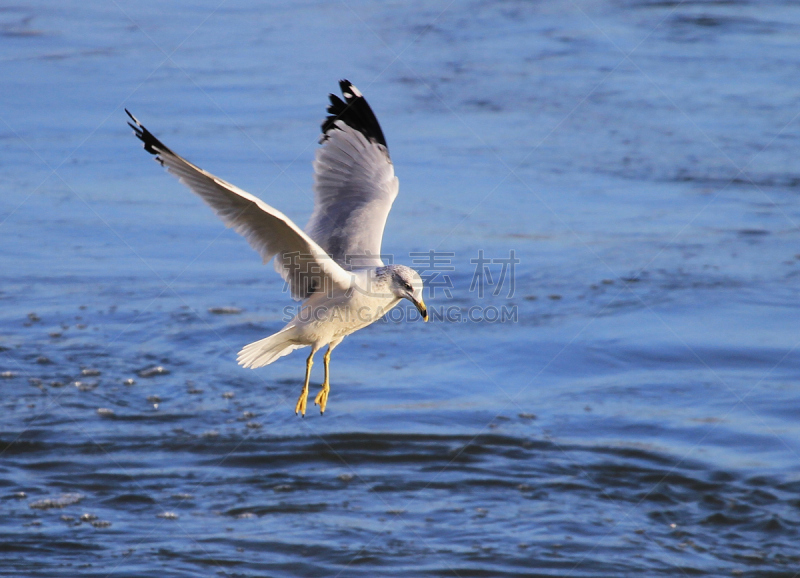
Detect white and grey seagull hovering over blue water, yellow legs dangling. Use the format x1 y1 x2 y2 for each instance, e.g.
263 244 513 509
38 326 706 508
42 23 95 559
125 80 428 416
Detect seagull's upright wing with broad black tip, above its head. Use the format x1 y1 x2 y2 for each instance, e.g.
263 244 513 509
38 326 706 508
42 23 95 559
306 80 399 270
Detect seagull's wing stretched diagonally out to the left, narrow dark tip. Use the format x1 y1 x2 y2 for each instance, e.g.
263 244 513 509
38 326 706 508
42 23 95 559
125 110 351 299
